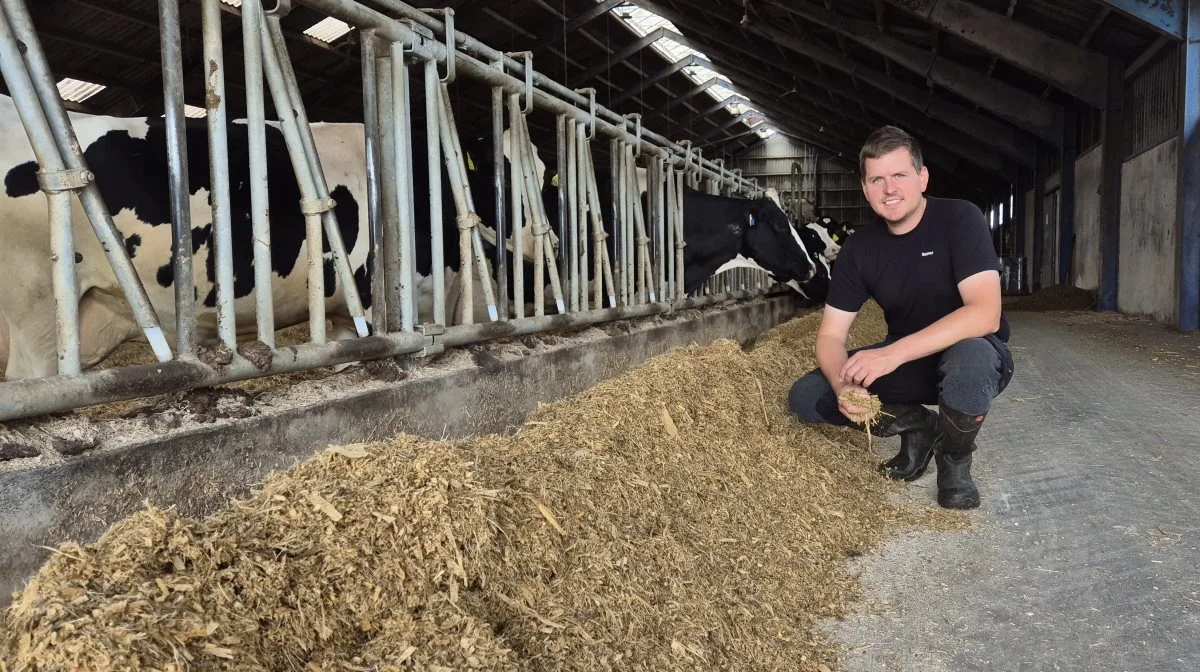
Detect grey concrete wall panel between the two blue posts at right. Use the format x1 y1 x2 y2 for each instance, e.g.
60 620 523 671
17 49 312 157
1117 138 1178 324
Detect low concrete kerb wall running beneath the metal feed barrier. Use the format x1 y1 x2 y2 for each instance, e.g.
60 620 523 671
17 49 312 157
0 293 799 606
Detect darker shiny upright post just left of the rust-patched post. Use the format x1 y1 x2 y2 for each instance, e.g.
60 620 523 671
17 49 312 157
158 0 196 359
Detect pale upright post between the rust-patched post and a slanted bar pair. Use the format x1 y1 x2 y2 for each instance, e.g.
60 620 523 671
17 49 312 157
241 0 275 348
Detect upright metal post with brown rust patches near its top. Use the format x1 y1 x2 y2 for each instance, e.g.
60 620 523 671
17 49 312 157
202 0 238 350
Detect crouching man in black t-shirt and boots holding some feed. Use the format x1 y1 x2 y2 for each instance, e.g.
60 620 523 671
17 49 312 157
788 126 1013 509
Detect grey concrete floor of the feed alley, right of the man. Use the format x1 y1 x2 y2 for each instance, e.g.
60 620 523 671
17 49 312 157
823 312 1200 672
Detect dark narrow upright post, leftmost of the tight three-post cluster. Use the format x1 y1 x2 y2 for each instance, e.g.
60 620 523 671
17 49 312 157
359 28 388 334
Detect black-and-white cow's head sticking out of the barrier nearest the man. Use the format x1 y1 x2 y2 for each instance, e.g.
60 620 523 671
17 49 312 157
740 198 816 283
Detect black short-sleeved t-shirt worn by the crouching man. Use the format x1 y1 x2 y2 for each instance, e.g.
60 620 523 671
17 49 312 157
826 197 1008 342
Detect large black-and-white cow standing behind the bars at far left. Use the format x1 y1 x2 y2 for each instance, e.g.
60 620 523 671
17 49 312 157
0 96 547 379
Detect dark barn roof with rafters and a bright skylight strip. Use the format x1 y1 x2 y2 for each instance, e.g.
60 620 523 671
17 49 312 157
2 0 1183 198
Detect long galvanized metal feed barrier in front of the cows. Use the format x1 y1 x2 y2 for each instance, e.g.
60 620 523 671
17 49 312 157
0 0 772 420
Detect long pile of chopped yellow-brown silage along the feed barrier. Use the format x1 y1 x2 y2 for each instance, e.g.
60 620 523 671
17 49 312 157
0 303 961 672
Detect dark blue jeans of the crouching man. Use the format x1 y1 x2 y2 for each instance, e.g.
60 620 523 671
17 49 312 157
787 336 1014 426
